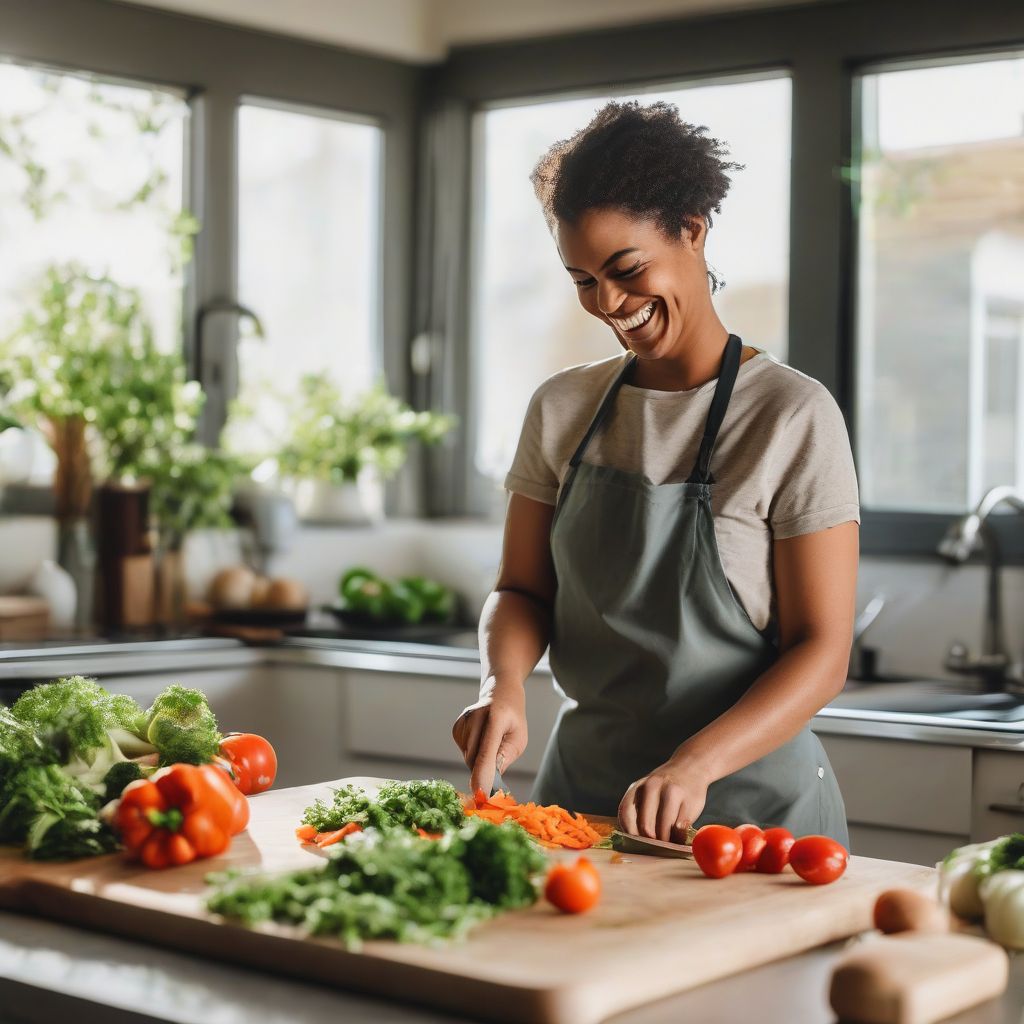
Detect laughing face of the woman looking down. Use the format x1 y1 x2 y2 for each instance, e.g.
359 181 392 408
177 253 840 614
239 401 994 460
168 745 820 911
555 209 708 359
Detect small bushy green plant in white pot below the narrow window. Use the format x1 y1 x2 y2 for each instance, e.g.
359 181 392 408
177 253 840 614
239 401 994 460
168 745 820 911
275 374 457 523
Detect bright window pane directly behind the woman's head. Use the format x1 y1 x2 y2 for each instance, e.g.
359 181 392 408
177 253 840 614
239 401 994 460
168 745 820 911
473 77 791 481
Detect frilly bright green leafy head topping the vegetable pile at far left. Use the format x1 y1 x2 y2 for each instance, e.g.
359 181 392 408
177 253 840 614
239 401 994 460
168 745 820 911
10 676 142 763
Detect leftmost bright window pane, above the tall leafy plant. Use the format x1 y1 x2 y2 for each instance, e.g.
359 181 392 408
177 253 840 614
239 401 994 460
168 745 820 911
0 63 188 351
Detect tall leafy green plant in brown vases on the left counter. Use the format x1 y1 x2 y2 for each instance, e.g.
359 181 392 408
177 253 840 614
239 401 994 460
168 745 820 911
4 264 203 626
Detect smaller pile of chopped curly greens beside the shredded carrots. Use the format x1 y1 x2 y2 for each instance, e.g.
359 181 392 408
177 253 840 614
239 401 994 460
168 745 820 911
302 779 466 831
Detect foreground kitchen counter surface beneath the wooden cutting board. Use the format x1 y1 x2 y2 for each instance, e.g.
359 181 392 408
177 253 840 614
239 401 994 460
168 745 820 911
0 913 1024 1024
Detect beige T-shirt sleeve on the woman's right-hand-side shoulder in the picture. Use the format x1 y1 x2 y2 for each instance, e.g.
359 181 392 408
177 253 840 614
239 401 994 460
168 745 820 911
768 382 860 541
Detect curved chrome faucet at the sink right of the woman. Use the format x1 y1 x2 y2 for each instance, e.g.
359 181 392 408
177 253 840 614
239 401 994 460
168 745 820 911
938 484 1024 690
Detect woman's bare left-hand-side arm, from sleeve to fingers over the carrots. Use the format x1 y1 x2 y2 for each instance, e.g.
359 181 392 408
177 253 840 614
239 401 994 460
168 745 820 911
452 494 555 794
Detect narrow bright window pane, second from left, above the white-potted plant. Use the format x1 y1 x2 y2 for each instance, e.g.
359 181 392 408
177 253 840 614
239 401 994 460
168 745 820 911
232 103 383 447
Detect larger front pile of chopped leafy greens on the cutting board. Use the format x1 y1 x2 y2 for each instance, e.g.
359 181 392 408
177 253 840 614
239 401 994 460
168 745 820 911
207 818 547 948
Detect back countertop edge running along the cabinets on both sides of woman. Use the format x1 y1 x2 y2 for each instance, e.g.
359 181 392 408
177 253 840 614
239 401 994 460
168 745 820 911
0 634 1024 752
